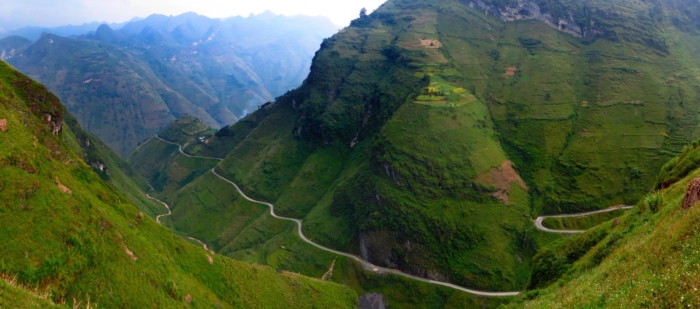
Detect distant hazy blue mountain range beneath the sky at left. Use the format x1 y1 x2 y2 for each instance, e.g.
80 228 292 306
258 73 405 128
0 13 335 157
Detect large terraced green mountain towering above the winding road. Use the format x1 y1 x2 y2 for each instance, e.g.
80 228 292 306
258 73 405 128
129 0 700 300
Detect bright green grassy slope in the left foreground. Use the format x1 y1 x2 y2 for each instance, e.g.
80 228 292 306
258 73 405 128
0 63 357 308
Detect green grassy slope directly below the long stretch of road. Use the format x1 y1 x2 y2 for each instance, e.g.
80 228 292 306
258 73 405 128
131 115 507 308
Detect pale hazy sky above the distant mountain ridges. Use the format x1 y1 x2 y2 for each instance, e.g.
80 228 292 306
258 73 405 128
0 0 385 30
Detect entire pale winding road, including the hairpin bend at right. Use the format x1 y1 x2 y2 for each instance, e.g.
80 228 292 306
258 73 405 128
148 135 634 297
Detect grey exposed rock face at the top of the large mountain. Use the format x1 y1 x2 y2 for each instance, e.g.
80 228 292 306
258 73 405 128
468 0 602 38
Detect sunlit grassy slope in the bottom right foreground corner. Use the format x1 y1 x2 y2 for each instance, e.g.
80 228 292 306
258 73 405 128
510 144 700 308
